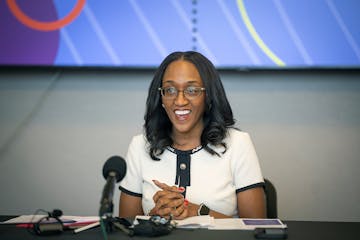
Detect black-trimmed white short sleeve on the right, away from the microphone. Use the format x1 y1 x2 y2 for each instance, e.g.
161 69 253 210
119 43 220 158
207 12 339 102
230 130 264 192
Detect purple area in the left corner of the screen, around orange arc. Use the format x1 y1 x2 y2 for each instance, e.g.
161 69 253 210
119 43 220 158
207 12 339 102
0 0 59 65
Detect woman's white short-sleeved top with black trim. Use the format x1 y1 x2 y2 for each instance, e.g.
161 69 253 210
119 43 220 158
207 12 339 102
120 128 264 216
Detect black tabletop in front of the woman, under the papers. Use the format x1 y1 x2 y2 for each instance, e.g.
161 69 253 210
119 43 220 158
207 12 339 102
0 216 360 240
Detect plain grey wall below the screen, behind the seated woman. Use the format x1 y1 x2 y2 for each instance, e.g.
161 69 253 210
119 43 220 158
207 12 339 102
0 68 360 221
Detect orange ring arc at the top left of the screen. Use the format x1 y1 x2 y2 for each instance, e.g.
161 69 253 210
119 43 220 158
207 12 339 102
6 0 86 31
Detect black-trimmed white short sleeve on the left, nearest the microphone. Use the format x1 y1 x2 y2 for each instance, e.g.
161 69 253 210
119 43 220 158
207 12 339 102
119 135 145 197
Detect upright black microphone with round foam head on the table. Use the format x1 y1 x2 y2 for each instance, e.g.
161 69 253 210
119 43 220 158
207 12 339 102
99 156 126 216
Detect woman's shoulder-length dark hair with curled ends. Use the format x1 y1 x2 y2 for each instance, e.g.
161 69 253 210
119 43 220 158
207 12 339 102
144 51 235 160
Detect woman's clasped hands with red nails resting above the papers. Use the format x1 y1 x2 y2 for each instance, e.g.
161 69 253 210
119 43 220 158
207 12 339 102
149 180 197 220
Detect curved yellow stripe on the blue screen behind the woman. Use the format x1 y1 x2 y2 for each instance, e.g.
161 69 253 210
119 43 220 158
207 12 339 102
237 0 285 66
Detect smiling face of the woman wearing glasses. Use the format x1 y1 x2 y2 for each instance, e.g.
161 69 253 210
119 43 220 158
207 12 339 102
162 60 205 135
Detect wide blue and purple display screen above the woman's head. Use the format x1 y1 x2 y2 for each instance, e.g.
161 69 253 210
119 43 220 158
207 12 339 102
0 0 360 68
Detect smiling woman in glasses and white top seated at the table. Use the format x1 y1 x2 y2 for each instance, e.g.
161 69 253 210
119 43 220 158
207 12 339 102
119 51 266 219
